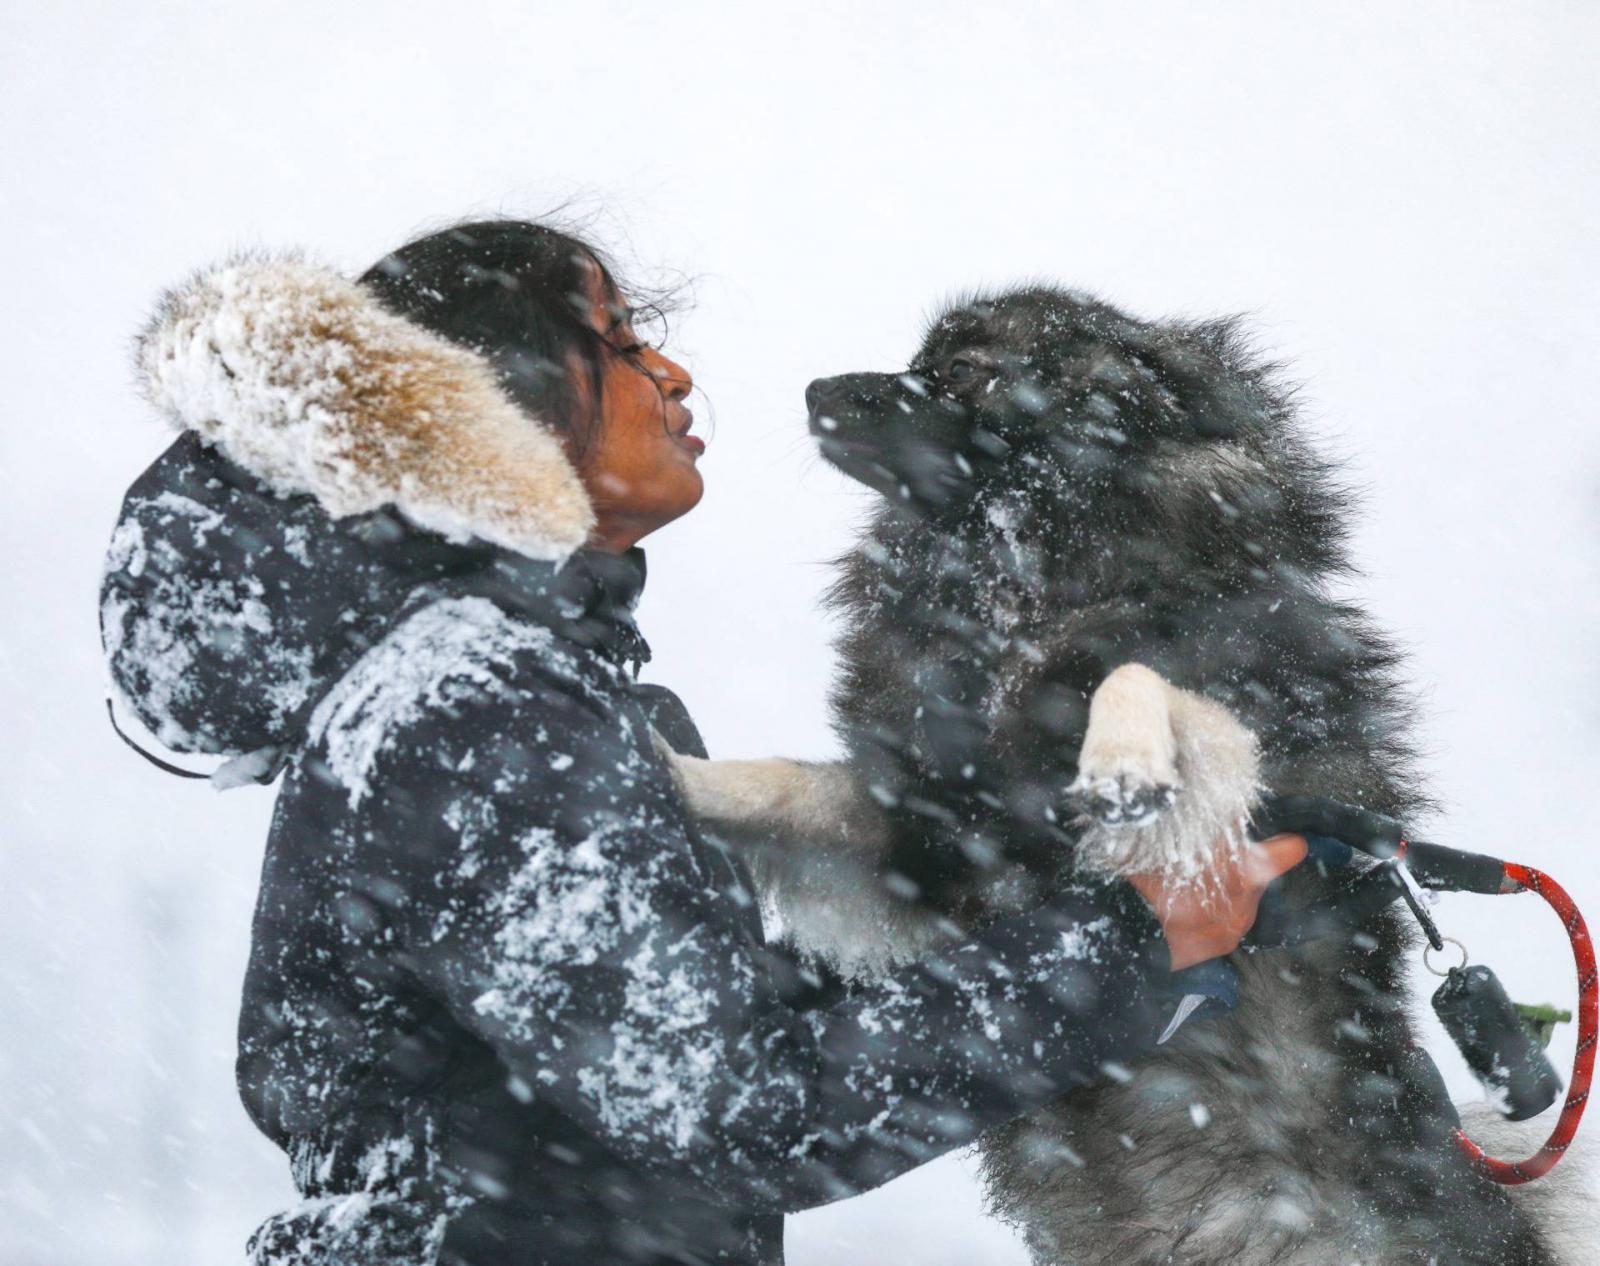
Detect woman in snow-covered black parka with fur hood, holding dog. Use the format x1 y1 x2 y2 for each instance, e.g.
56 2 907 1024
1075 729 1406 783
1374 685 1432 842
102 221 1304 1266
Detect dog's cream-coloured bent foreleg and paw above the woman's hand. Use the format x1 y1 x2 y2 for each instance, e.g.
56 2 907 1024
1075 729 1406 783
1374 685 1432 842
1069 664 1261 882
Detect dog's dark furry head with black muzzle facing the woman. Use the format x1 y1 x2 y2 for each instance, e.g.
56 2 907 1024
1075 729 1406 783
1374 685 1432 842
806 286 1275 514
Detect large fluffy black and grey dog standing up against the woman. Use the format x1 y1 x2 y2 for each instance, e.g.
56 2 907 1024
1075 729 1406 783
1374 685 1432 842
675 286 1578 1266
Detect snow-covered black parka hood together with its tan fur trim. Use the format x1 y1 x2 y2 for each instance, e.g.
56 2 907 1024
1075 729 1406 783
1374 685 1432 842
101 256 611 754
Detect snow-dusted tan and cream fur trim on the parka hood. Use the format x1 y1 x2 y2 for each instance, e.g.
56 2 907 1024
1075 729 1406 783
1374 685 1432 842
136 256 594 560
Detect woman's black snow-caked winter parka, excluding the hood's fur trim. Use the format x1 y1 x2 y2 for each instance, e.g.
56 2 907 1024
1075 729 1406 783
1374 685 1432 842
102 257 1171 1266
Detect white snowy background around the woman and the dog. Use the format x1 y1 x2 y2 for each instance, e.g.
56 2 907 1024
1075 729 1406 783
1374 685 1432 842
0 0 1600 1266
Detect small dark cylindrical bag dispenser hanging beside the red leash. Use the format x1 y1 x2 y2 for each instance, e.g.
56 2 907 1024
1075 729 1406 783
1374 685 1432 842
1434 967 1562 1120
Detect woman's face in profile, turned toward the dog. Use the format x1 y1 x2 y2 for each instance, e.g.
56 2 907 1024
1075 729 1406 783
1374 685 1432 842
578 269 706 554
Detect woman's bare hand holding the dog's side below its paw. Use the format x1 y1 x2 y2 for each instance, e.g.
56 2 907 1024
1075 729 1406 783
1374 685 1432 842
1128 835 1306 972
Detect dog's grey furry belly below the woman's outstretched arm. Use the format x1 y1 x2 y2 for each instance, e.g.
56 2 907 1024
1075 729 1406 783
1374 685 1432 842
984 959 1427 1266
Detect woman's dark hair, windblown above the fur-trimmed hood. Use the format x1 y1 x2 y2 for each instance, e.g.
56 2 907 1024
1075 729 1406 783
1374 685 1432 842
360 219 661 463
